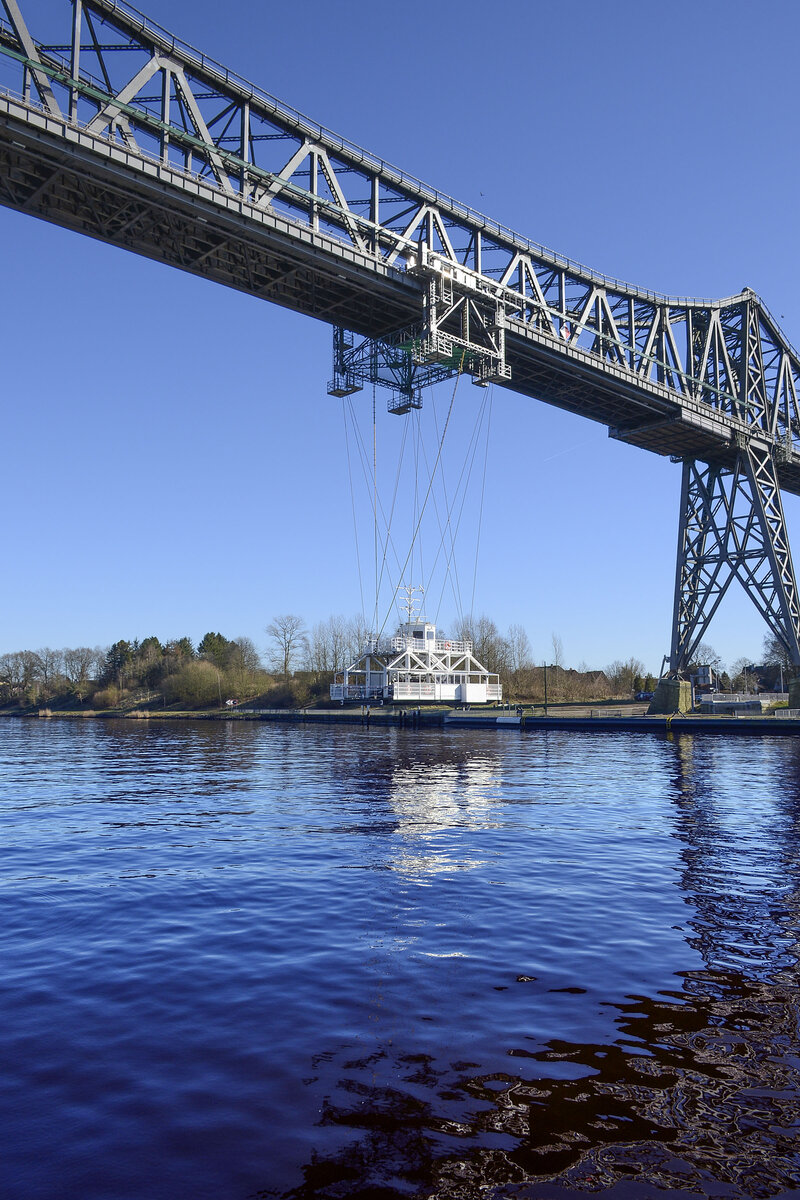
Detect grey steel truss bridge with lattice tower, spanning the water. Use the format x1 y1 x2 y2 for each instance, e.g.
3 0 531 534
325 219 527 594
0 0 800 677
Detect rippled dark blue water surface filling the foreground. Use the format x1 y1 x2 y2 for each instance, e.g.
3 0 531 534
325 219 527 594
0 720 800 1200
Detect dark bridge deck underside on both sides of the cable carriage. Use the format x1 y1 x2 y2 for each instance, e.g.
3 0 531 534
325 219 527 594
6 110 800 494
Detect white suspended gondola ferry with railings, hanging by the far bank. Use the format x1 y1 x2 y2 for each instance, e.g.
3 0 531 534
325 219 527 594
331 619 503 704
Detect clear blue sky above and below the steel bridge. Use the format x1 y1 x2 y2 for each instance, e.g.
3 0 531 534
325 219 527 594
0 0 800 671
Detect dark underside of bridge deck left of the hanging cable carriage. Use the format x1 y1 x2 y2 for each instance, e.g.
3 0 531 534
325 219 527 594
0 122 419 336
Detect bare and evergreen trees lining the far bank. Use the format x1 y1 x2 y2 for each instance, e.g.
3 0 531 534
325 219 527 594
9 613 794 709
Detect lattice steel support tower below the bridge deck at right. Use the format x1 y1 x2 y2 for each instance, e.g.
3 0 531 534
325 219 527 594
669 438 800 679
